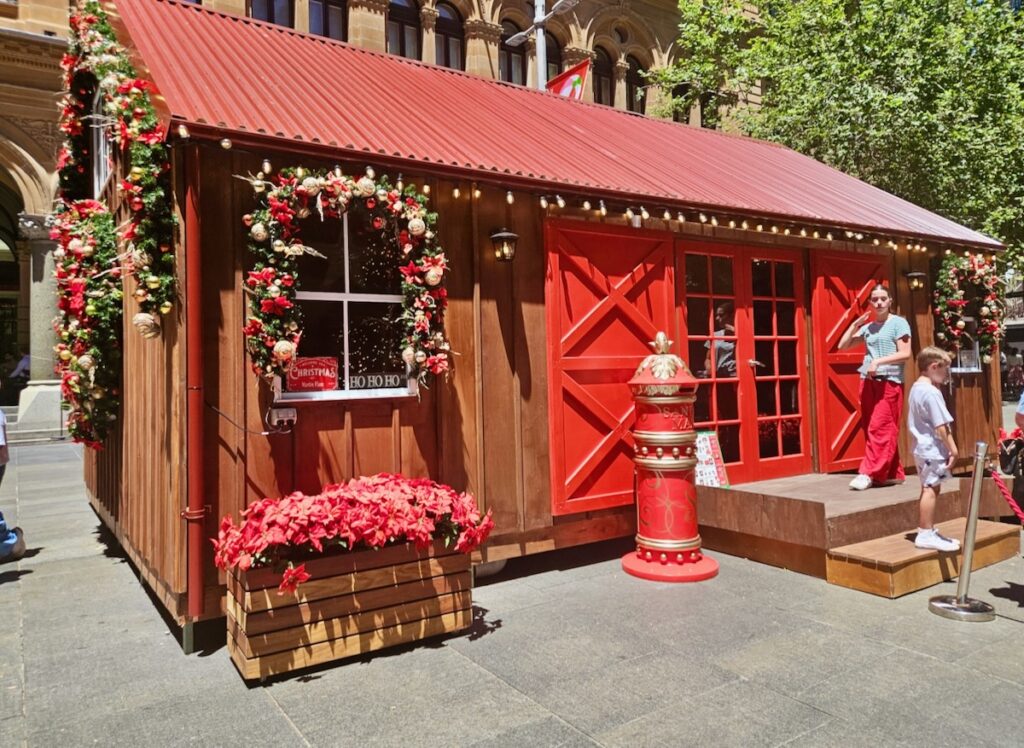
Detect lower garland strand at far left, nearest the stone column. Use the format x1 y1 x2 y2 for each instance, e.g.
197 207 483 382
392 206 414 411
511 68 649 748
50 200 123 448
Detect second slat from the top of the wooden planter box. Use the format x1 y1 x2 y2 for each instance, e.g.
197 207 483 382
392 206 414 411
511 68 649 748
227 573 470 635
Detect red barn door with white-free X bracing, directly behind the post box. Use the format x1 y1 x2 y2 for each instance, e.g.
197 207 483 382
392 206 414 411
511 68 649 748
545 221 676 514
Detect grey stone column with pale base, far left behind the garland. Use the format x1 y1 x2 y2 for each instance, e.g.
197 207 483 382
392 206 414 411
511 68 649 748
17 213 63 432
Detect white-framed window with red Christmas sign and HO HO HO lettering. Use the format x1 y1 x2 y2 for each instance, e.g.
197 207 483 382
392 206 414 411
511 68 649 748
282 211 411 400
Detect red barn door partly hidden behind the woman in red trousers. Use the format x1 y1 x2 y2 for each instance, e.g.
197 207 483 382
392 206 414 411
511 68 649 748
811 252 892 472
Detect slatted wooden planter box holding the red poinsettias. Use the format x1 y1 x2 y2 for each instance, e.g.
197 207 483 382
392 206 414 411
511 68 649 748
227 542 473 679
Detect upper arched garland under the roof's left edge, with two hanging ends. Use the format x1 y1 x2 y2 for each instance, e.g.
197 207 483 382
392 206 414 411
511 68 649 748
57 0 176 337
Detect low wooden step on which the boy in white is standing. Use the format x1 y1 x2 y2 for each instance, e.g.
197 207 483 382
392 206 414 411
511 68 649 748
825 517 1020 597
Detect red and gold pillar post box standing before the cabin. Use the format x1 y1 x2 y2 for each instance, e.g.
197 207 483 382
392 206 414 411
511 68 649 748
623 332 718 582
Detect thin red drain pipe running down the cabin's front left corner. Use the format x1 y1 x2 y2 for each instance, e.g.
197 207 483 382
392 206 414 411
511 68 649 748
181 144 207 655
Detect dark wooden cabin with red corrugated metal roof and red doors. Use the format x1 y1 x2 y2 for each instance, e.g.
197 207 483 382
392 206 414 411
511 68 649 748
85 0 1000 622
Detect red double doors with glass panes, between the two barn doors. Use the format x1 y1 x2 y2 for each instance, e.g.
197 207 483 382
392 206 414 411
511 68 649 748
677 242 811 484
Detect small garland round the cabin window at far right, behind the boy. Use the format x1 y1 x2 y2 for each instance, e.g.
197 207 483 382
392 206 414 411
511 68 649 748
933 253 1004 364
